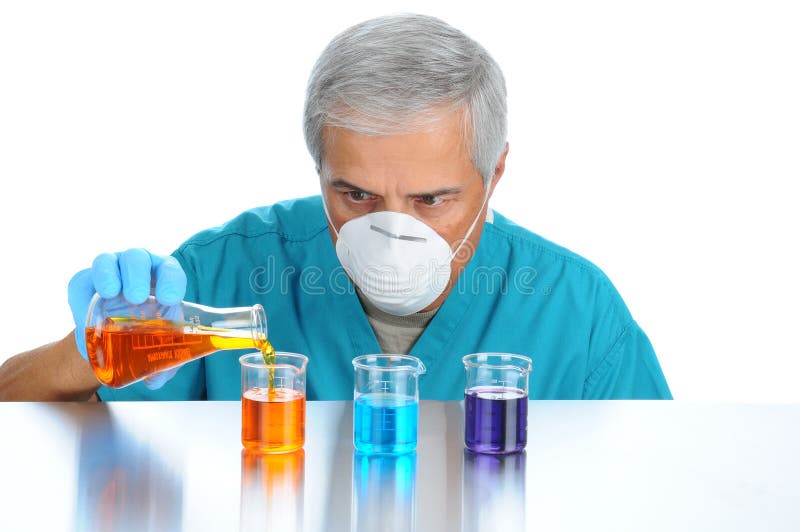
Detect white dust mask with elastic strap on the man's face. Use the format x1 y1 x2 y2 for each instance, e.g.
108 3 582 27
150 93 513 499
322 187 489 316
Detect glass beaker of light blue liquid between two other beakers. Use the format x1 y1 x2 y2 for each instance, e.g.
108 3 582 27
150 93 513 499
353 355 425 454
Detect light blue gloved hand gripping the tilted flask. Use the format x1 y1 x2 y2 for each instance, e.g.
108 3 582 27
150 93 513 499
68 248 186 390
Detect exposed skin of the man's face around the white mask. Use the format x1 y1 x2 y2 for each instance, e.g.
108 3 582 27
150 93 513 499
322 112 508 311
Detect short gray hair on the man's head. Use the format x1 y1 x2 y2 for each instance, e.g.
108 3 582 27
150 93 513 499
304 14 507 184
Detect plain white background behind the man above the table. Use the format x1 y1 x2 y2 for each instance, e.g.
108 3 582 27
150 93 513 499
0 0 800 401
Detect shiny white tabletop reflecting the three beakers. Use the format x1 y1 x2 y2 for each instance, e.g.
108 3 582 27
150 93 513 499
0 401 800 532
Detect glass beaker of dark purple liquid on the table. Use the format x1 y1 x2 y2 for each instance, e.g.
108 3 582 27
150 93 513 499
462 353 533 454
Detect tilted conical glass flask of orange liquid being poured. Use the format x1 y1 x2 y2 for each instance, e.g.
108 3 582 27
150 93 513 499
86 294 272 388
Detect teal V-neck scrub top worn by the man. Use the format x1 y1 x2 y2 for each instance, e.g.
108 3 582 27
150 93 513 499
99 196 671 400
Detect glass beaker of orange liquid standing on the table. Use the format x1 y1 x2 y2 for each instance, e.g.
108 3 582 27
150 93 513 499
239 352 308 453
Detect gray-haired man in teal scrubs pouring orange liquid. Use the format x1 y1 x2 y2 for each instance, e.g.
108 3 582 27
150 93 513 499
0 15 670 400
